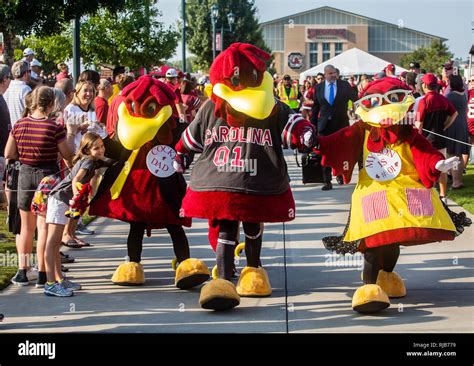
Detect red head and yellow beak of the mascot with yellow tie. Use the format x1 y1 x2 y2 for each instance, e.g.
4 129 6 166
117 75 176 150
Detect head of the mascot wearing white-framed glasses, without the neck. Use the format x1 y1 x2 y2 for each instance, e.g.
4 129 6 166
355 77 415 127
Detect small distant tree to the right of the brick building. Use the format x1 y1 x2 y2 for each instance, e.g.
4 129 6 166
400 41 453 74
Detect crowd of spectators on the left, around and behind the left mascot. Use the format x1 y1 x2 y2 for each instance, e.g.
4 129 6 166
0 48 208 296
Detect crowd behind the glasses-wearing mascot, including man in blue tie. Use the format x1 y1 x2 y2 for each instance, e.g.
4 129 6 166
274 62 474 192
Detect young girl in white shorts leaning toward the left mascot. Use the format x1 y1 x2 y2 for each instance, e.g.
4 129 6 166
44 132 105 297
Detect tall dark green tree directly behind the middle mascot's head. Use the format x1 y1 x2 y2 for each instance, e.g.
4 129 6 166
186 0 271 70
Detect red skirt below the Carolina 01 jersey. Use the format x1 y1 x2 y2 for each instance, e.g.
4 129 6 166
182 188 295 222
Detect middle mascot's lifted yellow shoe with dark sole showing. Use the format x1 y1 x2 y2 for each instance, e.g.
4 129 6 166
199 278 240 310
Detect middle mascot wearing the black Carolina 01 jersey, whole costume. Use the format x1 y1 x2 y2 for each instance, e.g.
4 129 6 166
176 43 314 310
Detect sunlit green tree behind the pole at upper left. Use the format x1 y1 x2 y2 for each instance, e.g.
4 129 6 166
20 0 179 69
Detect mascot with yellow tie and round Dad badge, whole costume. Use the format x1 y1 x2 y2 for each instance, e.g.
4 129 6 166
90 76 209 289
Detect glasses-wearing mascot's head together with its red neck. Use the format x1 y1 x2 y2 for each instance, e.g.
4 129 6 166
354 77 415 152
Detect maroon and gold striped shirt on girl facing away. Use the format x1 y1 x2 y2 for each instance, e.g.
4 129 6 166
11 117 66 166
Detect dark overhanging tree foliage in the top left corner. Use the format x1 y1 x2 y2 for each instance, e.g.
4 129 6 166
0 0 125 64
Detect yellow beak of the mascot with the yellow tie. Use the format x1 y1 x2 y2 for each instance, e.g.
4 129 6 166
117 102 172 150
